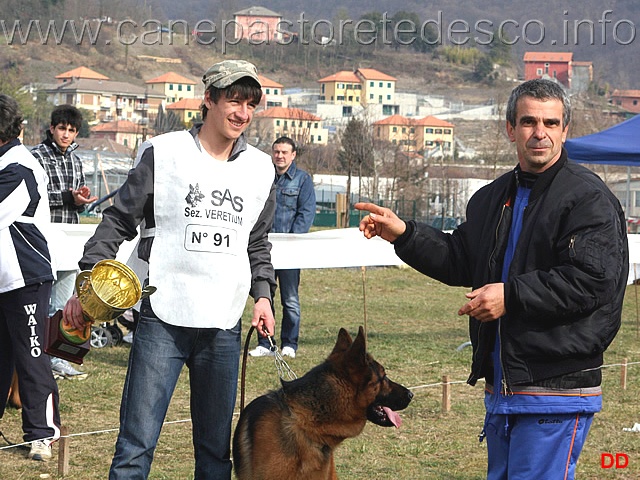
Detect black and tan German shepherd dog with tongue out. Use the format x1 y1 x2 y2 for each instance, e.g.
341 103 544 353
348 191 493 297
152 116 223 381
233 327 413 480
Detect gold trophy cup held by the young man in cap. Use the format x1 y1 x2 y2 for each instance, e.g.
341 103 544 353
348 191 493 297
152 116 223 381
45 260 156 364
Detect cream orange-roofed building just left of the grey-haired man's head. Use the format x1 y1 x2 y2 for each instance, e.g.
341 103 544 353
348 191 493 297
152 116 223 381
372 115 455 155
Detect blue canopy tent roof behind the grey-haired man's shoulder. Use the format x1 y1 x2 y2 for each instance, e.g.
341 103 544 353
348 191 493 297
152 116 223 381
564 115 640 167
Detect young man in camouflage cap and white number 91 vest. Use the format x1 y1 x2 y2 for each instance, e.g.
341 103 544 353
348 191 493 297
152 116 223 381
64 60 275 480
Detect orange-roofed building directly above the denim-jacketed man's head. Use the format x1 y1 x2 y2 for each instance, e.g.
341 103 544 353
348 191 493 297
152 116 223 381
249 107 329 148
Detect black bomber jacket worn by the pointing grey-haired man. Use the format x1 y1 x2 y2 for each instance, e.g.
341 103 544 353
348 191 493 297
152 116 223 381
394 149 629 388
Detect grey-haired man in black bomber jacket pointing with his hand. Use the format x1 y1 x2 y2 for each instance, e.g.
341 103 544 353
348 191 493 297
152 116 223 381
356 80 629 480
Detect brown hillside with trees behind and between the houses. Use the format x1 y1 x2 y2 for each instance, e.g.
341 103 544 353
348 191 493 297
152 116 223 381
0 0 640 221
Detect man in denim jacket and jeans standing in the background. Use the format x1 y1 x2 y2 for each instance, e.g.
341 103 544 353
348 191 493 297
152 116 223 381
249 137 316 358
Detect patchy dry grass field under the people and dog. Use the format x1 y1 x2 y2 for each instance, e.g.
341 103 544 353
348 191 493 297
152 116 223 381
0 268 640 480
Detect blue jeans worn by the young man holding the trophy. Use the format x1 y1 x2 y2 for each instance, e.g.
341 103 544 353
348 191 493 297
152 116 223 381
109 300 241 480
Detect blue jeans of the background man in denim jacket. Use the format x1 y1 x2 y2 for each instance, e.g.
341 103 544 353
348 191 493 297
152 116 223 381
258 269 300 351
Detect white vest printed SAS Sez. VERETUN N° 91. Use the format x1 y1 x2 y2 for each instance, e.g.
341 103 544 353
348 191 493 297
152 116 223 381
141 131 274 329
